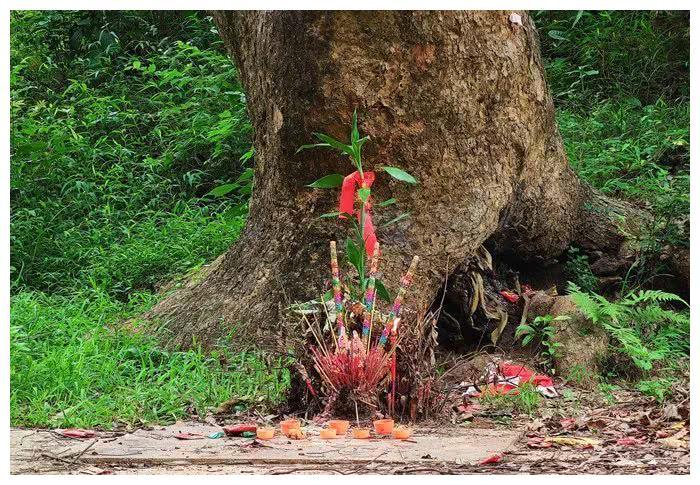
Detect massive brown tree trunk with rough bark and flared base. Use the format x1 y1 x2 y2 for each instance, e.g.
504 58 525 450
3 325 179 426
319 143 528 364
151 12 640 346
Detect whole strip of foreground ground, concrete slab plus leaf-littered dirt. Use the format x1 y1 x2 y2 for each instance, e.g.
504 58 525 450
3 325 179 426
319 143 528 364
11 384 690 475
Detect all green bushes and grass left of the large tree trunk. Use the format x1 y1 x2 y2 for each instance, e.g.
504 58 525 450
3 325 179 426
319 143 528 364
11 11 280 427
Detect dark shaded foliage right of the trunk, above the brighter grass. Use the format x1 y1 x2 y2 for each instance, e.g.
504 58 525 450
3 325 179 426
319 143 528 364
534 10 690 110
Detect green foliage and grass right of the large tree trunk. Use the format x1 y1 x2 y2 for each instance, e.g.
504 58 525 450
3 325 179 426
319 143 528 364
535 11 690 264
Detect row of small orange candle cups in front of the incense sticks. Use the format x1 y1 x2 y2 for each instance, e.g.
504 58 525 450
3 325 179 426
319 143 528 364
257 419 411 440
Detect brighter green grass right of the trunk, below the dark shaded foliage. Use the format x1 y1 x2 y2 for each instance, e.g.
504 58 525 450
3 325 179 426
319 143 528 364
557 98 690 252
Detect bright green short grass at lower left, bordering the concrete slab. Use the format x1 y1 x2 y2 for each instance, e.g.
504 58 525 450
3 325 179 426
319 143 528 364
10 292 289 428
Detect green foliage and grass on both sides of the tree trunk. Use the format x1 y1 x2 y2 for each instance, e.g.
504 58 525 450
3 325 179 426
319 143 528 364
10 11 690 427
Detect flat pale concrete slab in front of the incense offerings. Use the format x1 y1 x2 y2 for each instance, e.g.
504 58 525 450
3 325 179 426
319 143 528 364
10 423 522 473
